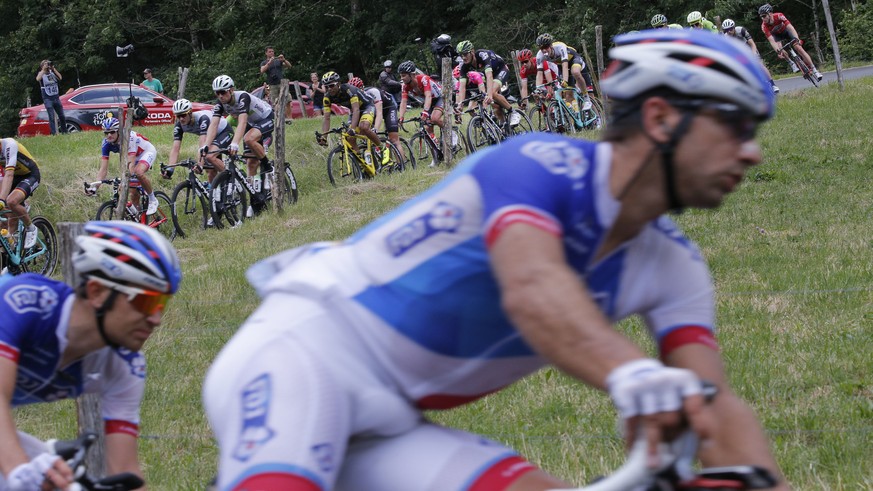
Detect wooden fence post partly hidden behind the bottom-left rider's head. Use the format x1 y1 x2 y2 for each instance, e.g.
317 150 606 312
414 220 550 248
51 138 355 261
58 222 106 478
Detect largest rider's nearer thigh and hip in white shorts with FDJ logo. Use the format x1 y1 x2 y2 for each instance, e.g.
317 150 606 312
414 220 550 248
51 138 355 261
203 294 352 491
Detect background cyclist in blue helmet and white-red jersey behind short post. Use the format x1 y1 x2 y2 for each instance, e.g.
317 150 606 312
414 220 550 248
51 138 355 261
86 117 158 215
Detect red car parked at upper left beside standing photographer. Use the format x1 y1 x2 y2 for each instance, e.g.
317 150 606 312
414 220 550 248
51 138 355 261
18 83 212 136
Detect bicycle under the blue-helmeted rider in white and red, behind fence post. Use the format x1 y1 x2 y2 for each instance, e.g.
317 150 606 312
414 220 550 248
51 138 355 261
84 177 178 240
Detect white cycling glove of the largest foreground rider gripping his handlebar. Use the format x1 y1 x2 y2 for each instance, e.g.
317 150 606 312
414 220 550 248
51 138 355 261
606 358 703 419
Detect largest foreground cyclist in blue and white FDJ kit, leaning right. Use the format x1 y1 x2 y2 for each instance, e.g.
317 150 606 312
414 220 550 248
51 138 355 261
203 29 787 491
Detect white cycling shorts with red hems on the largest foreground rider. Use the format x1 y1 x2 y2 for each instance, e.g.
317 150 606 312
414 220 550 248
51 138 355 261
203 293 535 491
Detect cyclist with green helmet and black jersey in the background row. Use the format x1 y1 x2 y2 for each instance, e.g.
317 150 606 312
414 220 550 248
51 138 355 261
455 41 512 134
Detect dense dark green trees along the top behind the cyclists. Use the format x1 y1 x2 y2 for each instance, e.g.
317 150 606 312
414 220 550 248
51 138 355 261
0 0 871 134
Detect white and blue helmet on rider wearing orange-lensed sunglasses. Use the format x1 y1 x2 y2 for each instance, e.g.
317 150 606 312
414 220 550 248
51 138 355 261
73 220 182 293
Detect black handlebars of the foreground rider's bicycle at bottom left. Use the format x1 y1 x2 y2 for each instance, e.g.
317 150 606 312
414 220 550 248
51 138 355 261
46 431 145 491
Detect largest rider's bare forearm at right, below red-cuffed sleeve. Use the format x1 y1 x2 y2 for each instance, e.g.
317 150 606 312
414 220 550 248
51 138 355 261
665 344 789 490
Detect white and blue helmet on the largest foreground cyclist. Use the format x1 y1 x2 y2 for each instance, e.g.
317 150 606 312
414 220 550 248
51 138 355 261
601 29 776 120
